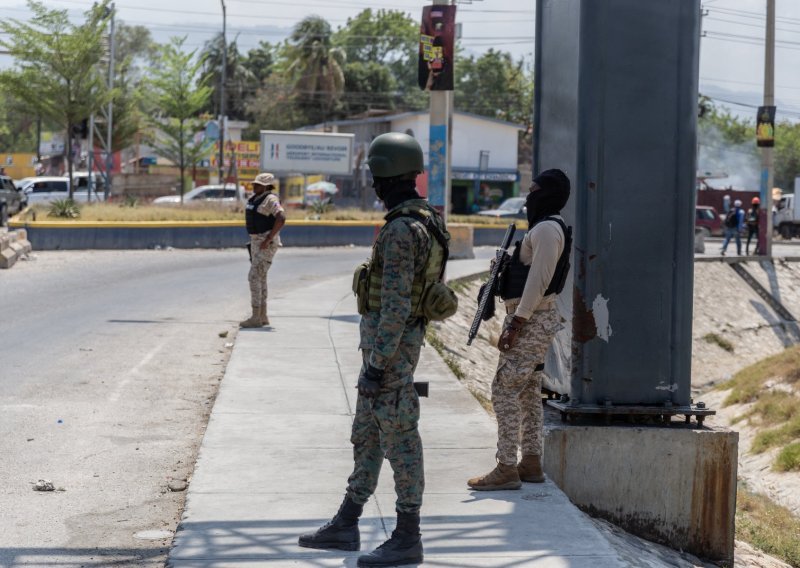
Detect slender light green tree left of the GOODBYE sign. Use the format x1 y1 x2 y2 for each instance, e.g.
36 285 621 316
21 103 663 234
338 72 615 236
150 37 212 203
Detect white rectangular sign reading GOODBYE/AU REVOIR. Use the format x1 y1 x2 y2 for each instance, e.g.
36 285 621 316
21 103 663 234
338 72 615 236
261 130 355 175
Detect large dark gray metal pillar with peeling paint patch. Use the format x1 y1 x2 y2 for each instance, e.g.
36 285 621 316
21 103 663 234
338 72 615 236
534 0 700 407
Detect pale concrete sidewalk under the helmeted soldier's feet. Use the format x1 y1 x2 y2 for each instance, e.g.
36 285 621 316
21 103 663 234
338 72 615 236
168 260 625 568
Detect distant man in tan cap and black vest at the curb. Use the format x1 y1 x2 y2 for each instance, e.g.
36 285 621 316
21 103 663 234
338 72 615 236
239 173 286 327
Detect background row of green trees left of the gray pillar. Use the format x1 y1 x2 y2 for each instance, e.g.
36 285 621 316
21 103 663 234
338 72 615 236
0 0 533 197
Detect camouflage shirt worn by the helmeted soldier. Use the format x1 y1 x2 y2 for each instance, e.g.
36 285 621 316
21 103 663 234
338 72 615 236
359 199 444 385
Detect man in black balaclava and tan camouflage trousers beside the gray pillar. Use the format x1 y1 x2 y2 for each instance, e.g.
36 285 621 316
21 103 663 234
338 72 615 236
467 170 570 491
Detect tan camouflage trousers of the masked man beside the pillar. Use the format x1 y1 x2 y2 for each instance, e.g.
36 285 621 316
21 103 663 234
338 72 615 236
492 308 561 465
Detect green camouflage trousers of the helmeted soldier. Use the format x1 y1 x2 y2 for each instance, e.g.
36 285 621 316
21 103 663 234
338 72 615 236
347 350 425 513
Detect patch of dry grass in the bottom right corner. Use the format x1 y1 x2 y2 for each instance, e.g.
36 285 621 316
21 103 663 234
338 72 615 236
736 482 800 568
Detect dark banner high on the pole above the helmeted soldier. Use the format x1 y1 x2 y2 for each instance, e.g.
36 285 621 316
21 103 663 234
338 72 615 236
418 4 456 91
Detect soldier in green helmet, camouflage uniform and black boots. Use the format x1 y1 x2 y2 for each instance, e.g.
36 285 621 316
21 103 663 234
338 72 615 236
299 133 447 566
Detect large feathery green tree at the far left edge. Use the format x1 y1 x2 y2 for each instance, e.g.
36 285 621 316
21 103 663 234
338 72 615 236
0 0 114 198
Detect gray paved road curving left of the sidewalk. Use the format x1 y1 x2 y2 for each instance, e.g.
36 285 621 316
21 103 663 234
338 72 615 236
0 248 368 567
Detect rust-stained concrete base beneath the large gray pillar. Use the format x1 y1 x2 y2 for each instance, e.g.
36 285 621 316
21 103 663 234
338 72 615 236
544 425 739 564
